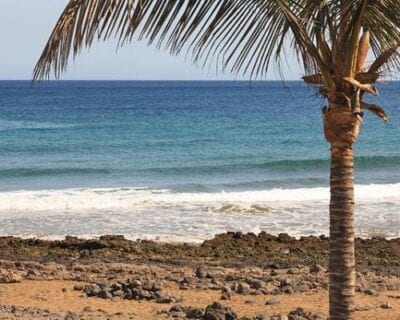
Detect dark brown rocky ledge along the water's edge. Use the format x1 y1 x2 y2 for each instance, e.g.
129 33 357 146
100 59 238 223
0 232 400 275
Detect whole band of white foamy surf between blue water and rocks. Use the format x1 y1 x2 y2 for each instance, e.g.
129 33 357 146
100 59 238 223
0 183 400 241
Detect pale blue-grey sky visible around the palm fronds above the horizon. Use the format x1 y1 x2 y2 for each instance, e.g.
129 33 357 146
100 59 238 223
0 0 302 80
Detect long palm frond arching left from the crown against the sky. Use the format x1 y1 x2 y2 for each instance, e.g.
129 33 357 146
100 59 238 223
33 0 334 79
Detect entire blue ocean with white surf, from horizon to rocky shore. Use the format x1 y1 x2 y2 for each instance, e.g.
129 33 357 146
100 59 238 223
0 81 400 242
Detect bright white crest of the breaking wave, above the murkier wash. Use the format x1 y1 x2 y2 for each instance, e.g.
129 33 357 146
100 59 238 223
0 183 400 214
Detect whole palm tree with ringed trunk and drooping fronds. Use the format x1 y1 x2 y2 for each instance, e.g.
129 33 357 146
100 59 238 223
33 0 400 320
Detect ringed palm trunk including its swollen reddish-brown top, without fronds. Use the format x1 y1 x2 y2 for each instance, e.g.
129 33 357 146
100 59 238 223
324 106 361 320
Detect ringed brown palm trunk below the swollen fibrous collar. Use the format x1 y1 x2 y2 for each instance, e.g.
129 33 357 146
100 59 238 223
329 142 355 320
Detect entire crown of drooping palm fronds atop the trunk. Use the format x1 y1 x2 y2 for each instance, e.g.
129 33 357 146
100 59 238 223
33 0 400 91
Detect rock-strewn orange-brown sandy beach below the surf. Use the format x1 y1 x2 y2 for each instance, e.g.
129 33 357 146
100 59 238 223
0 233 400 320
